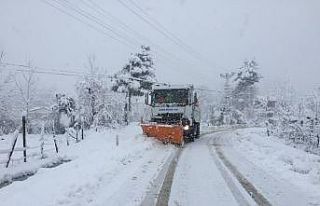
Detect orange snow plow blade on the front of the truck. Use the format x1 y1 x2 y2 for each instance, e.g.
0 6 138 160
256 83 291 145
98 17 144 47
141 124 183 145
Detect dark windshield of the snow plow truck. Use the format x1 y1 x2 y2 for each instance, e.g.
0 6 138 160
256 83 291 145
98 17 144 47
153 89 188 105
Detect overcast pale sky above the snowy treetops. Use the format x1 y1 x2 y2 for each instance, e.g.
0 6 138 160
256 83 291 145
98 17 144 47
0 0 320 94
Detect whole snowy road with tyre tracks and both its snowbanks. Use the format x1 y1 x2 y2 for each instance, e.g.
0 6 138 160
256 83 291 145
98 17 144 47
0 125 320 206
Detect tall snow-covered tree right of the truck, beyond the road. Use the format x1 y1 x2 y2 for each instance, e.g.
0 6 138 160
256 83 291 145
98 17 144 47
213 60 261 124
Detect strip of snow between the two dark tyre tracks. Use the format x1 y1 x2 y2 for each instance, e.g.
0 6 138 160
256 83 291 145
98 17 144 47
169 131 253 206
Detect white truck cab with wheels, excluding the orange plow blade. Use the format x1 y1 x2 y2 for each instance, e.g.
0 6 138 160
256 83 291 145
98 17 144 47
146 85 200 141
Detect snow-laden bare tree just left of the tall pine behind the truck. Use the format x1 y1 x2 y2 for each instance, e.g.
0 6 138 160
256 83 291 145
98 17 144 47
77 57 124 127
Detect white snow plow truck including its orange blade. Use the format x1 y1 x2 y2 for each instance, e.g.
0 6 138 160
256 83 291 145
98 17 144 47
141 85 200 146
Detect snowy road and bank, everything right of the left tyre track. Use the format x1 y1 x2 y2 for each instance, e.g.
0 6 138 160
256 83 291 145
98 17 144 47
169 128 320 206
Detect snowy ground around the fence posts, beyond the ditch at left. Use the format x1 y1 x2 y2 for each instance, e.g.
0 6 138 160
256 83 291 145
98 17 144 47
0 130 75 187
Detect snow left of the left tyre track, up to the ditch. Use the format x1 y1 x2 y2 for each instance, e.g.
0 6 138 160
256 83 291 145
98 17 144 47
0 124 176 206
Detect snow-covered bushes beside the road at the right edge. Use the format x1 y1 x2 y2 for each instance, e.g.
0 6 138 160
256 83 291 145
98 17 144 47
268 86 320 154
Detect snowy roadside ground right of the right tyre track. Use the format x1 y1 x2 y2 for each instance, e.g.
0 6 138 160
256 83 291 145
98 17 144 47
212 128 320 205
